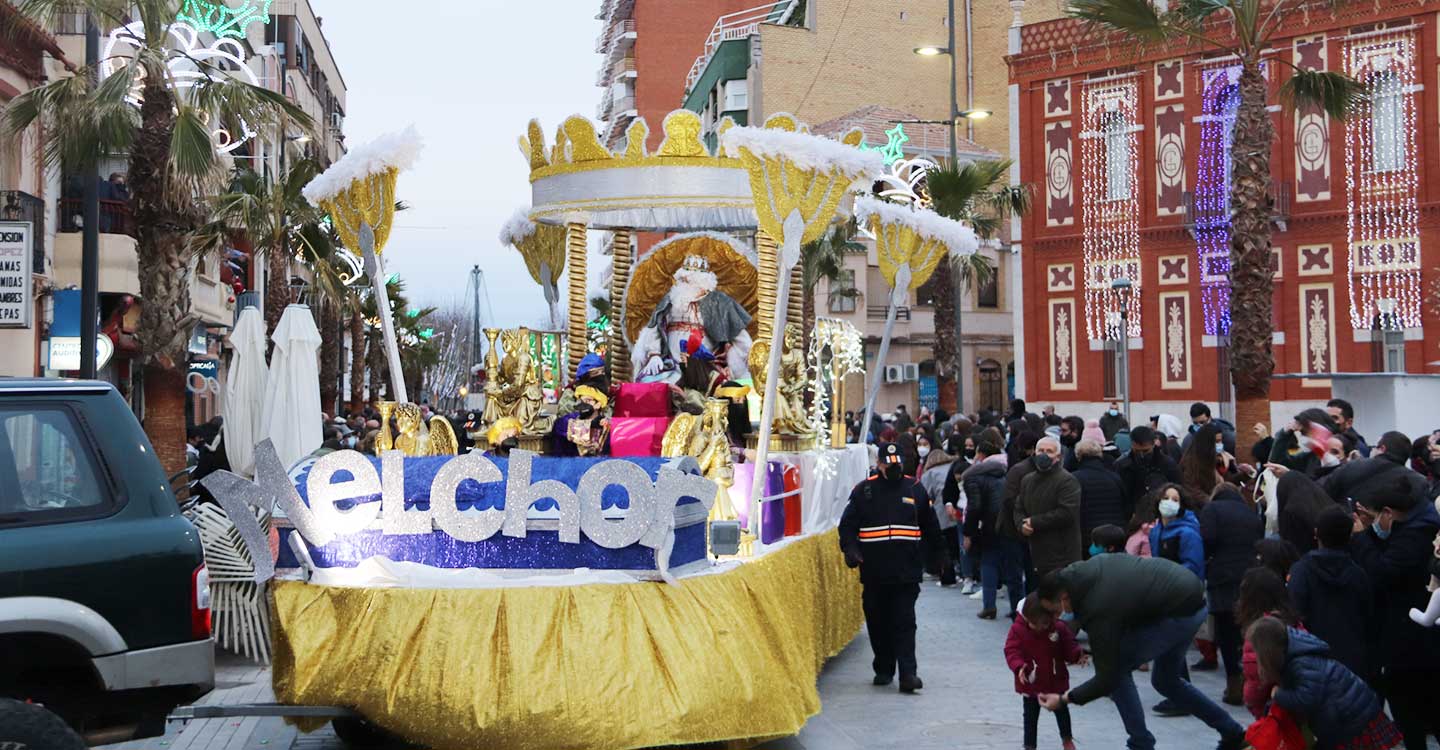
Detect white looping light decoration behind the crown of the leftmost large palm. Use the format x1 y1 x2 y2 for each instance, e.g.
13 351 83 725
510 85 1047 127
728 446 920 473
99 20 261 154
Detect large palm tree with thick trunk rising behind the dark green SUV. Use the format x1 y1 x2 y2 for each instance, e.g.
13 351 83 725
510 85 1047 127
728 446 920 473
4 0 311 472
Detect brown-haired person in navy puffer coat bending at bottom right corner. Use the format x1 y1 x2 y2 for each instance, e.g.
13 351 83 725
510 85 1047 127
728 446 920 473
1246 618 1403 750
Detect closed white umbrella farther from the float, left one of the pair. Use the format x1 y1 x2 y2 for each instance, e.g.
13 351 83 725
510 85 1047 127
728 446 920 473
222 307 268 476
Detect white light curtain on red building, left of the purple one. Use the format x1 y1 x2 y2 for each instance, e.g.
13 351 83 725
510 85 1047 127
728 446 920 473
1080 73 1140 340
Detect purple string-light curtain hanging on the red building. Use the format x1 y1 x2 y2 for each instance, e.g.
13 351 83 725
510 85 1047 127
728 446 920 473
1192 66 1240 335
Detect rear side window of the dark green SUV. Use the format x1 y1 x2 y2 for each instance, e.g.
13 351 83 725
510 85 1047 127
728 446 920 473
0 405 111 525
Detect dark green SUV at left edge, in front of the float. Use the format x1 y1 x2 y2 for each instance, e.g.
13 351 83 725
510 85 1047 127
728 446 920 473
0 379 215 749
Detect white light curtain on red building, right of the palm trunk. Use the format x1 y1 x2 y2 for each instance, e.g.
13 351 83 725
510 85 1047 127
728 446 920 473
1345 27 1421 330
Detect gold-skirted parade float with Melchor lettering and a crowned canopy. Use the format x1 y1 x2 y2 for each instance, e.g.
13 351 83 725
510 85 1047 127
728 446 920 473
206 111 976 749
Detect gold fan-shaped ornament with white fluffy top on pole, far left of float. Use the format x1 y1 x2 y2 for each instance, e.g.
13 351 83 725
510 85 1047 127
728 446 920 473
302 127 422 403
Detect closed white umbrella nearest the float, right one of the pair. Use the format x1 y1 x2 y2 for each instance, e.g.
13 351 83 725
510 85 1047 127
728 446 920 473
264 305 324 468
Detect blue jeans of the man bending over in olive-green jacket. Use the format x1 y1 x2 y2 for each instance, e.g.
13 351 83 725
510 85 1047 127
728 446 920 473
1110 606 1244 750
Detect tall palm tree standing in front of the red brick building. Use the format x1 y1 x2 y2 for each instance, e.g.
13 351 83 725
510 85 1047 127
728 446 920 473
1070 0 1364 451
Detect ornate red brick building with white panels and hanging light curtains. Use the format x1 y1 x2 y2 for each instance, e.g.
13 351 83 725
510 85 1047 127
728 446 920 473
1009 0 1440 419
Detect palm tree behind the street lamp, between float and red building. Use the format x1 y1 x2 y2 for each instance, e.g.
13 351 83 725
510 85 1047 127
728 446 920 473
924 154 1030 409
